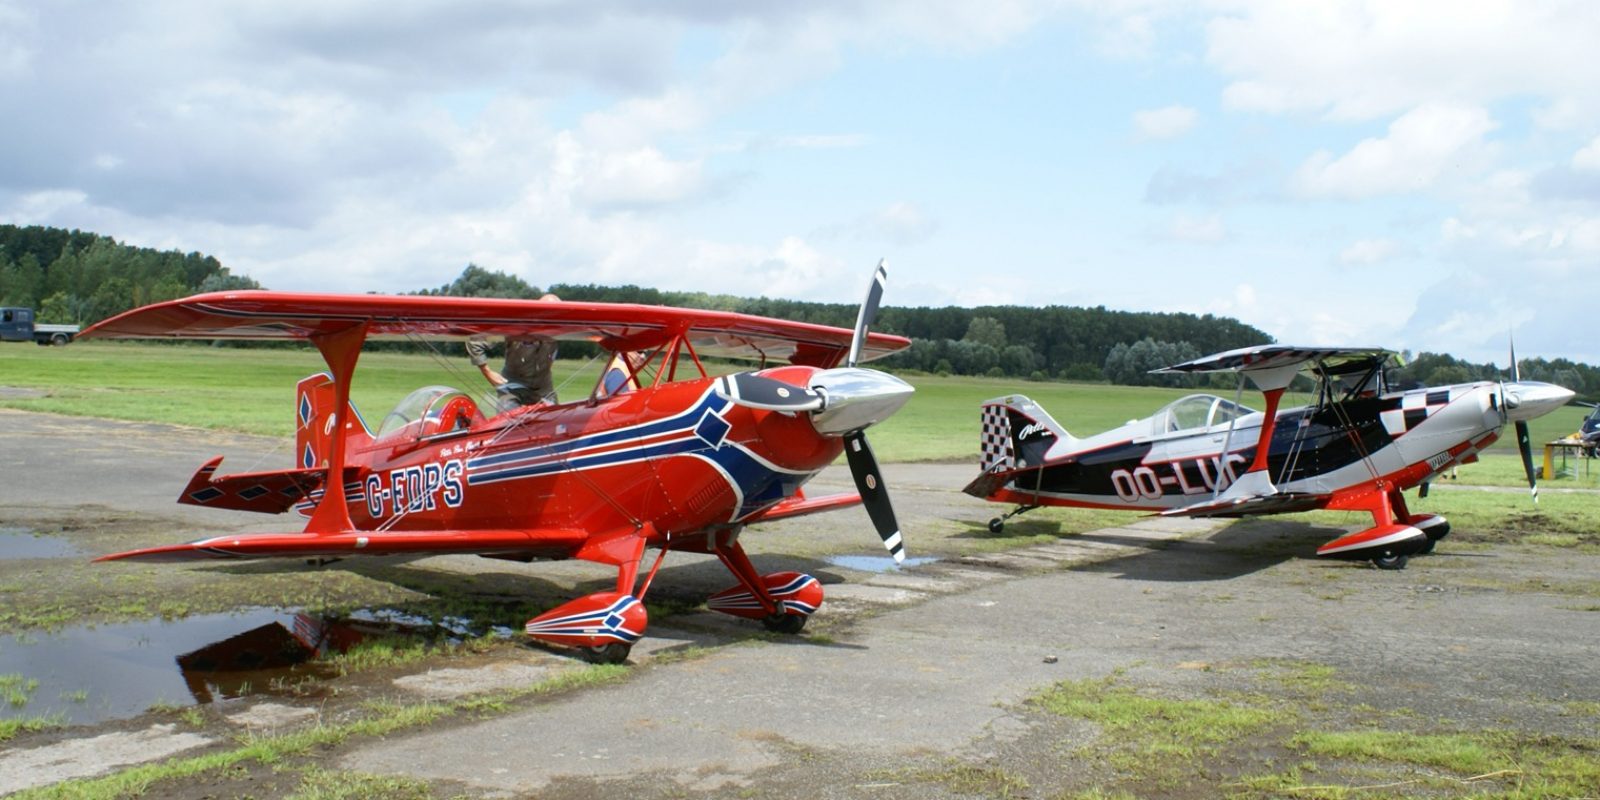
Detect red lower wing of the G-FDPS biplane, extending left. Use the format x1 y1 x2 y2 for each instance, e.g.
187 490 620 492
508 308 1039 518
94 528 589 562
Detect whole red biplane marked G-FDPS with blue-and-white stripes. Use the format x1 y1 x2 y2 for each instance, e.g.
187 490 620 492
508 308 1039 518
83 264 912 662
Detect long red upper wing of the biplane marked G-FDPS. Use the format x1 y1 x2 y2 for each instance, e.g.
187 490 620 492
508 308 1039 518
80 291 910 366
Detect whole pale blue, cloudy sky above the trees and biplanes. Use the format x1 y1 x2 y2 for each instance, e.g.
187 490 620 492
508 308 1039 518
0 0 1600 363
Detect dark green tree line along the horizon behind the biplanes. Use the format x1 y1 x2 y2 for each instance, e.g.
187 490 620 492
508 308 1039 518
0 226 1600 398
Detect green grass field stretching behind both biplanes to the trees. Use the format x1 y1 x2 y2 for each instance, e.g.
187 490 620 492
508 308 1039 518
0 342 1600 467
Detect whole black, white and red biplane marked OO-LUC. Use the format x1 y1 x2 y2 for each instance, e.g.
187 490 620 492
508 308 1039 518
966 344 1573 570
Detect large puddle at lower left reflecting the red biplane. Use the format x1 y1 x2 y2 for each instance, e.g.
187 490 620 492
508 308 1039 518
0 608 509 723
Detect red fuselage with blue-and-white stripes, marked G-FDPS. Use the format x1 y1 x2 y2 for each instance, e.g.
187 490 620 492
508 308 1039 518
308 366 843 555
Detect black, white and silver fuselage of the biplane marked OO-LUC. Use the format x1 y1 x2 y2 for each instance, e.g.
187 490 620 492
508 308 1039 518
973 381 1571 510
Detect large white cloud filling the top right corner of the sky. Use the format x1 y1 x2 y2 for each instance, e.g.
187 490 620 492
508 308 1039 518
1206 0 1600 120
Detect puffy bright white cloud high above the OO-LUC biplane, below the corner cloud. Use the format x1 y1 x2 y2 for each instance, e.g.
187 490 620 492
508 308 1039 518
1293 104 1494 198
